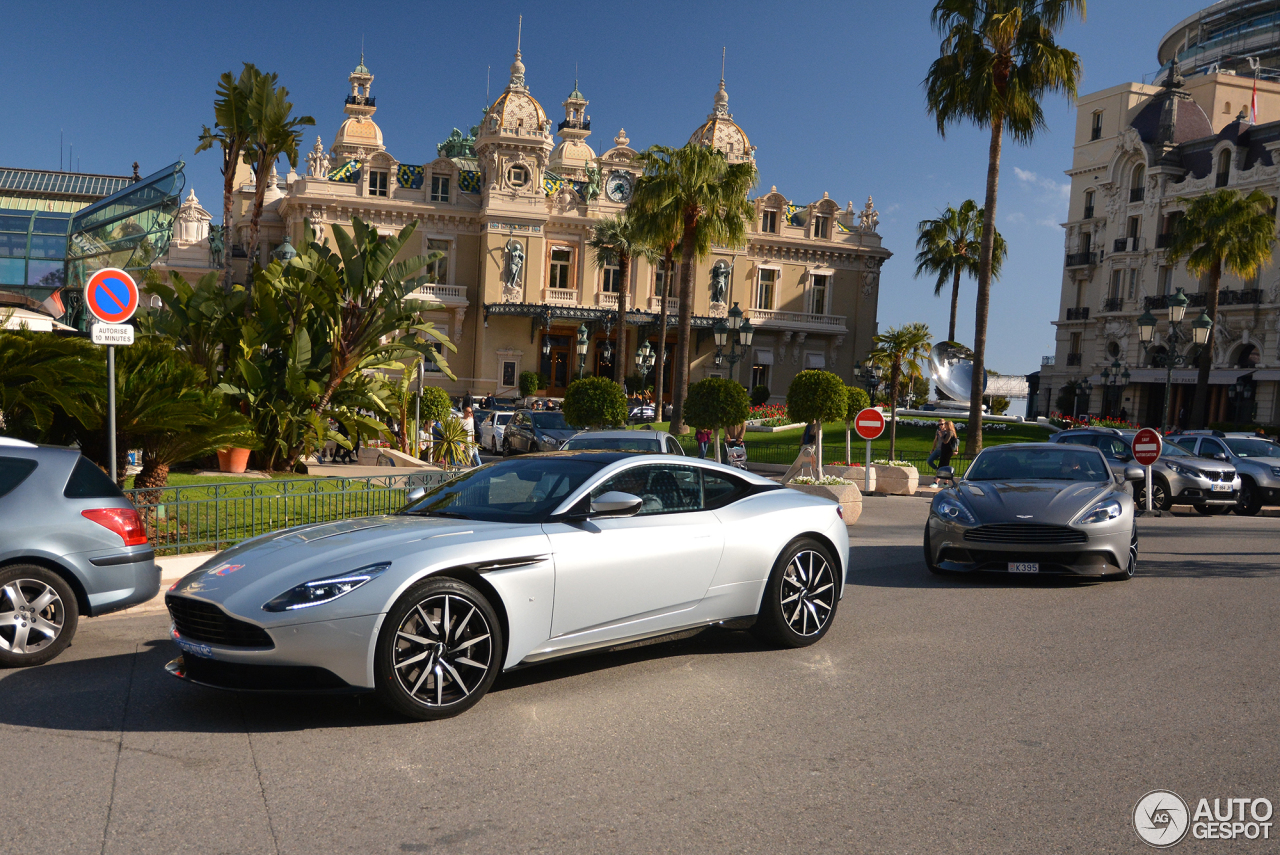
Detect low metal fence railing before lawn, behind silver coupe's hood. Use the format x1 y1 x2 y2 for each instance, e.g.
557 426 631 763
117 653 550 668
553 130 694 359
124 472 452 554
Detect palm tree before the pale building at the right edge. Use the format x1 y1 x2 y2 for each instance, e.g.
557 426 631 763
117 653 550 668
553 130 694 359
1165 189 1275 428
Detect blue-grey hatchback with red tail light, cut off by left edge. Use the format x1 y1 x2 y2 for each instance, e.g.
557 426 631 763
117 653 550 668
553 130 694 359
0 436 160 667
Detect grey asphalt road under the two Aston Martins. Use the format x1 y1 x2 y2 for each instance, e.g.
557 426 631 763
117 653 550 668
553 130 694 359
0 498 1280 855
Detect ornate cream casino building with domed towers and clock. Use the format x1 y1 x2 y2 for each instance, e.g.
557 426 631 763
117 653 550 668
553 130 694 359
155 50 891 399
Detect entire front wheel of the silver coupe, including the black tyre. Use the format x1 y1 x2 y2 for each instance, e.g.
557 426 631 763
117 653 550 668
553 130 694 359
375 576 503 721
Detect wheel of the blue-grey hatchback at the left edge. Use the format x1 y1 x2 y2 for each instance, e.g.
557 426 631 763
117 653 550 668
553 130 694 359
0 564 79 668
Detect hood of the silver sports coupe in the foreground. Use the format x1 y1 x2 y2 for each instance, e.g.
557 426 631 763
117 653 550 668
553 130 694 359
170 515 545 623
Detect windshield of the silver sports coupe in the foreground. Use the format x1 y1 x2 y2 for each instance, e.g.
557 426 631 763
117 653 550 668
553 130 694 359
402 457 604 522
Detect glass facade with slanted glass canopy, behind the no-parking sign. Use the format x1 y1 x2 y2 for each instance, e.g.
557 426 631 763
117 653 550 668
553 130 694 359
0 160 186 330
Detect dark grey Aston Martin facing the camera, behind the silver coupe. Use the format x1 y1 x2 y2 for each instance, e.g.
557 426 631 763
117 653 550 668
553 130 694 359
924 443 1143 579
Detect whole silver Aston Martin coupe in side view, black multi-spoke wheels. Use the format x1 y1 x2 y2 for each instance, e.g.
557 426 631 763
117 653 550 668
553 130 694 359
165 452 849 719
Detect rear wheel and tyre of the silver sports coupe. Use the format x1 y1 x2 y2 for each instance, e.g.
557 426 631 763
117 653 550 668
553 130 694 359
751 538 840 648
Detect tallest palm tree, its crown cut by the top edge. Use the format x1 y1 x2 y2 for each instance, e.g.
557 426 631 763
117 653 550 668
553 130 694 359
924 0 1084 454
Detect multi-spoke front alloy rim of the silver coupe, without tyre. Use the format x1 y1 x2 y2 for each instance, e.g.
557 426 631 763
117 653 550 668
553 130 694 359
392 593 494 709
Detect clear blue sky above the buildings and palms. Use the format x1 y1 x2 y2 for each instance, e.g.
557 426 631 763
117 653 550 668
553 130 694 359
0 0 1207 374
